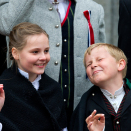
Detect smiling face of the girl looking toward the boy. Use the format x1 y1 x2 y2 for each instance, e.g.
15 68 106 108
13 34 50 82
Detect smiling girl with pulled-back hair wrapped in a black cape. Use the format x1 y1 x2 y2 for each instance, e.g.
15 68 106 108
0 22 66 131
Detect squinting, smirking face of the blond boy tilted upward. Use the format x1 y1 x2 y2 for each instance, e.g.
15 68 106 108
85 46 119 85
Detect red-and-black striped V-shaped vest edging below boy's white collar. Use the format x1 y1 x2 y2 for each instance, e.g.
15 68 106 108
102 82 129 131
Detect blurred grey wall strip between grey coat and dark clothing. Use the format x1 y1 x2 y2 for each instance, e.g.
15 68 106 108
94 0 119 46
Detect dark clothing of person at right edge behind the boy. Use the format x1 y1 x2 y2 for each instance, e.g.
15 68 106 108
118 0 131 80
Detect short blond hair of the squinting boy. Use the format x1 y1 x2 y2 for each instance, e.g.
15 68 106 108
83 43 127 78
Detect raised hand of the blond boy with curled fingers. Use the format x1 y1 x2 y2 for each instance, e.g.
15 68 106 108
86 110 105 131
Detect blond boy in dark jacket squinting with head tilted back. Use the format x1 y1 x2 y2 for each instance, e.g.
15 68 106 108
71 43 131 131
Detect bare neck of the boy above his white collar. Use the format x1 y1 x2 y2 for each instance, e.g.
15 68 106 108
98 79 123 95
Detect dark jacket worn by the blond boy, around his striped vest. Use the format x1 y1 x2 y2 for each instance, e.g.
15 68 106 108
70 86 131 131
